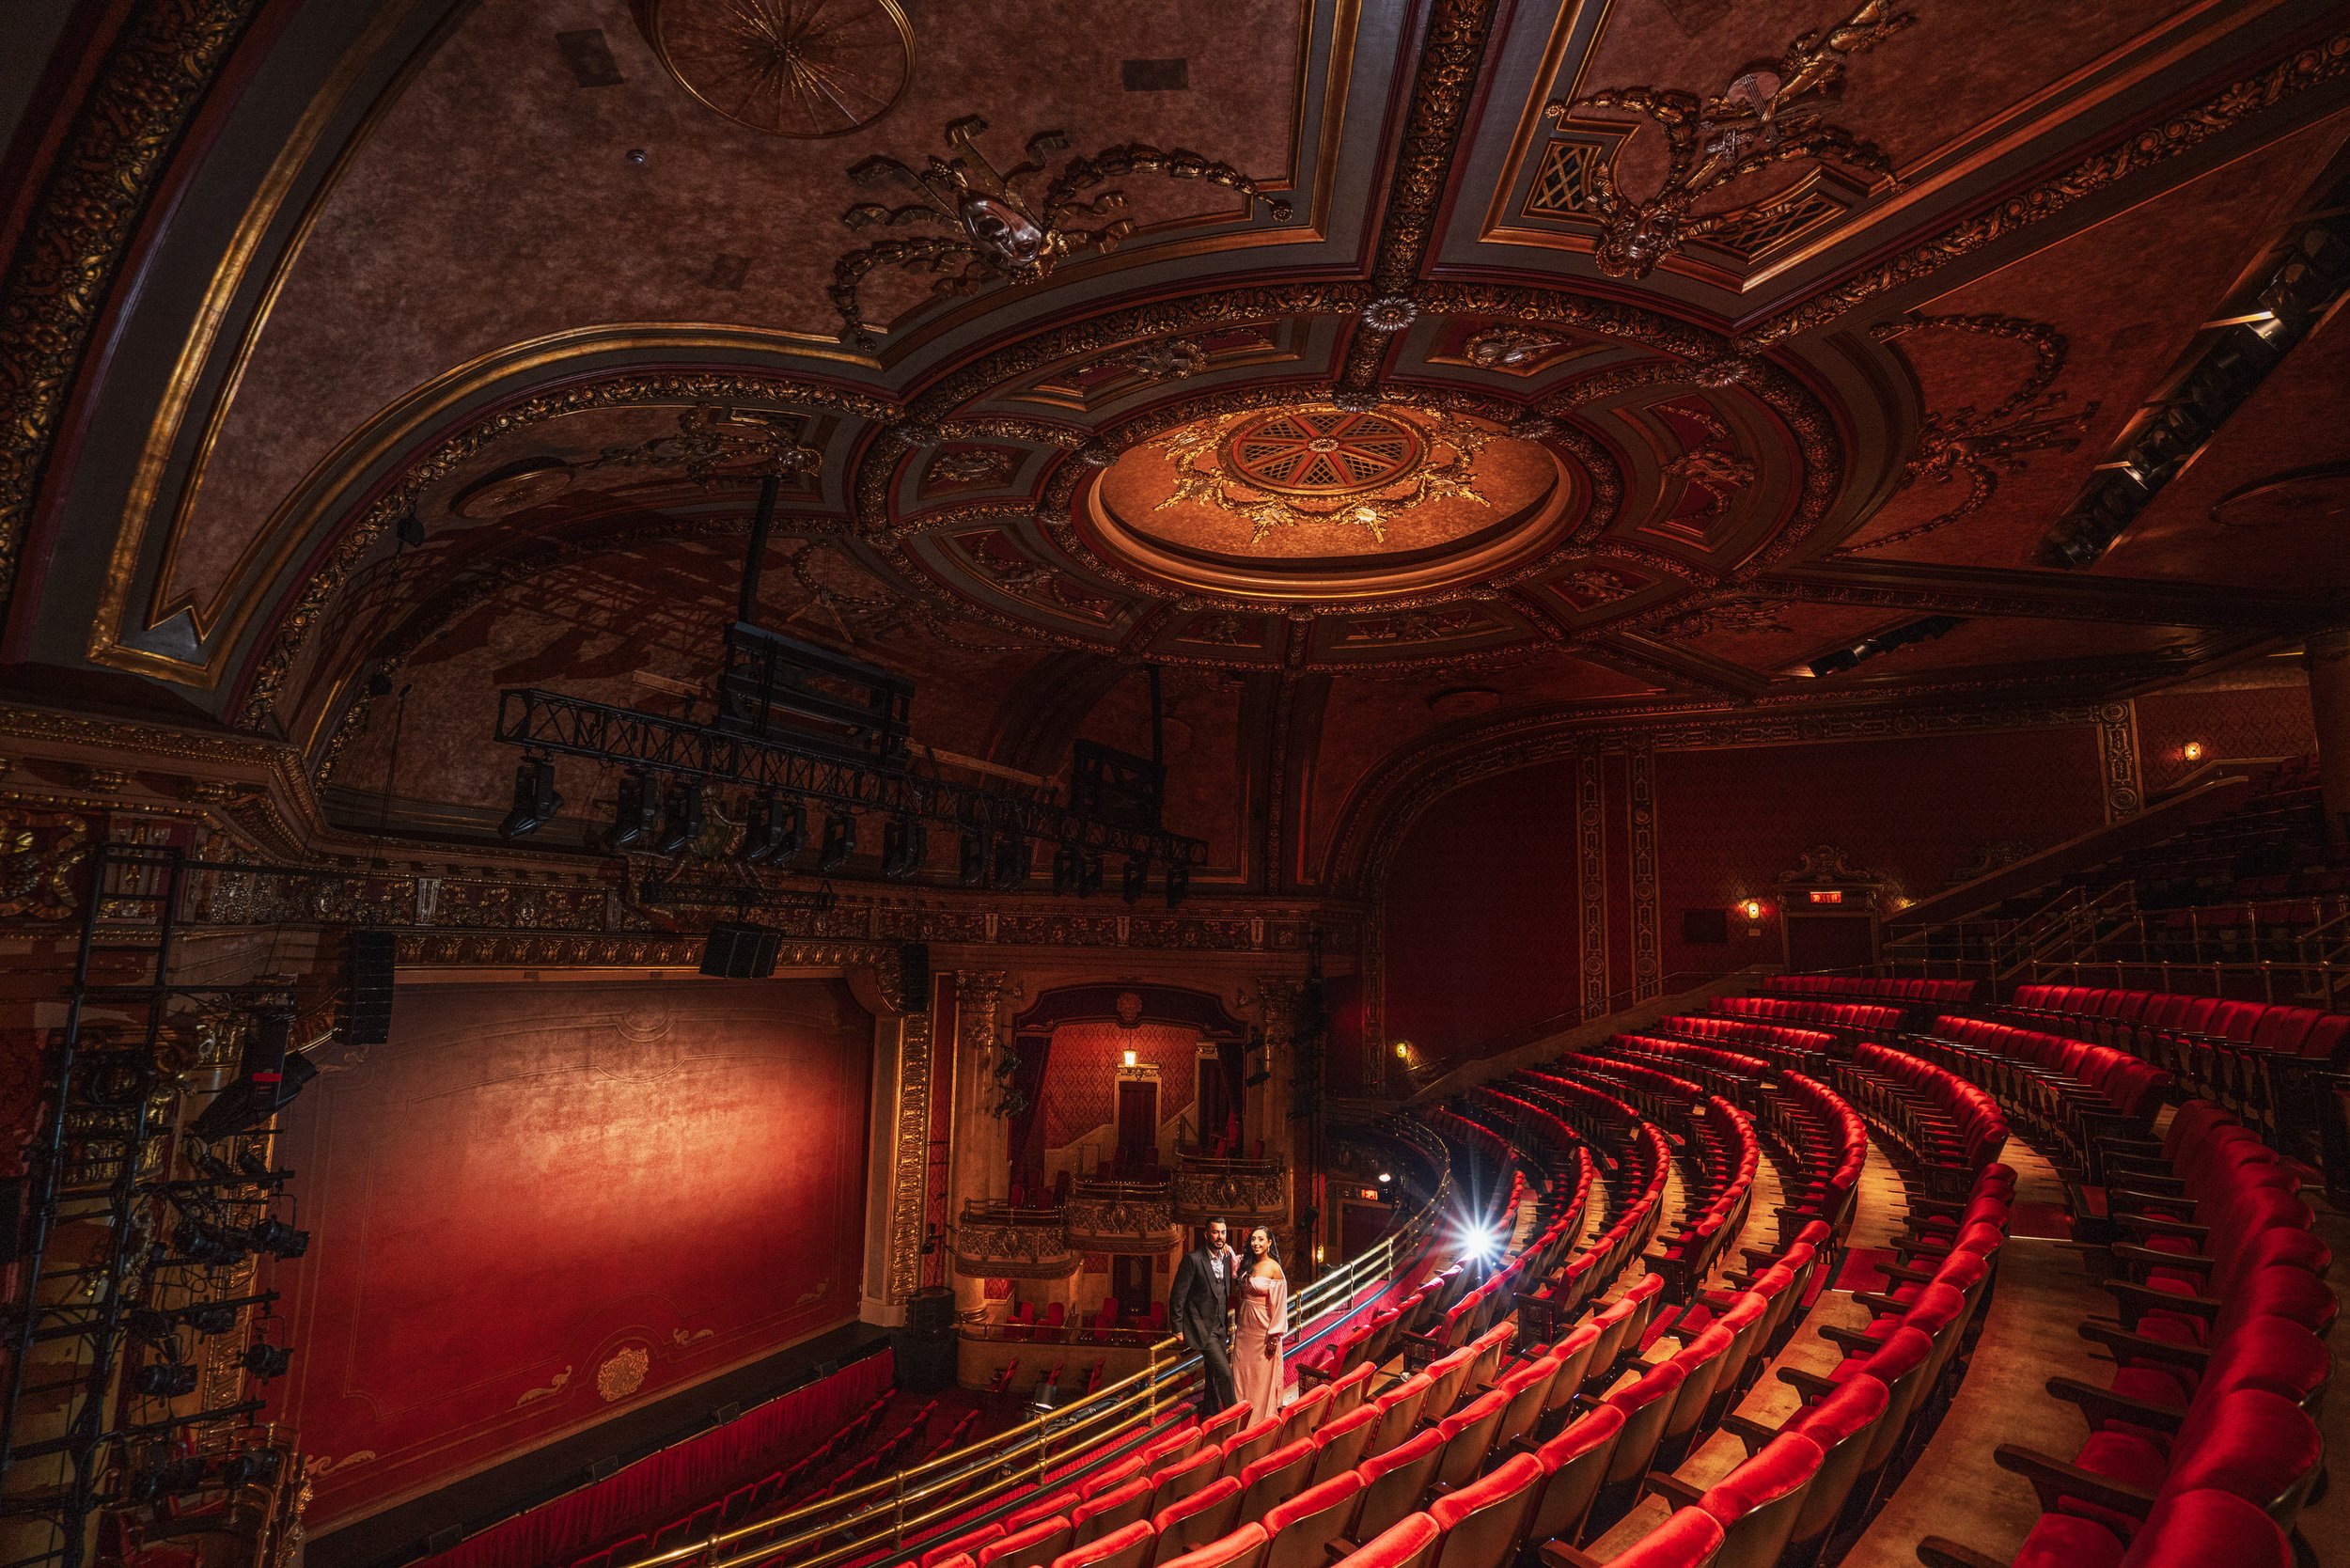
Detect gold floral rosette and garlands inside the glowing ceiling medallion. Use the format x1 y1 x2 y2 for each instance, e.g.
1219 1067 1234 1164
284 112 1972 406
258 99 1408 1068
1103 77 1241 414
1154 404 1488 543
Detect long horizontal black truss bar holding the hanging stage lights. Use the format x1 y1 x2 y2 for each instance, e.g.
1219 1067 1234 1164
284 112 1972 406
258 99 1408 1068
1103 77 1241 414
498 686 1208 868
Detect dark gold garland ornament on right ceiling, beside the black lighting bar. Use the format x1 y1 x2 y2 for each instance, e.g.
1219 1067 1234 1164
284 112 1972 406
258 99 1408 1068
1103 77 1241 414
1828 313 2096 559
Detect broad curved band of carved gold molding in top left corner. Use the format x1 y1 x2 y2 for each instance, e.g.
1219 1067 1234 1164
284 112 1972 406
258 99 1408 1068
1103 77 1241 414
0 0 261 604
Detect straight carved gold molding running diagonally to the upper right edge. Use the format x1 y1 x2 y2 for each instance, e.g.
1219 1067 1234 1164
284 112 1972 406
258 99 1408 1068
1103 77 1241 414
1747 28 2350 346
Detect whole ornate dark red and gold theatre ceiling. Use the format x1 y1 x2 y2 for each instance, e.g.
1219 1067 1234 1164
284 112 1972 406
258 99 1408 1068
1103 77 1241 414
0 0 2350 888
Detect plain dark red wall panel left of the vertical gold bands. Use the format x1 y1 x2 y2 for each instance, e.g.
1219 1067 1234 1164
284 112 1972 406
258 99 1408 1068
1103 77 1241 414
1385 764 1577 1058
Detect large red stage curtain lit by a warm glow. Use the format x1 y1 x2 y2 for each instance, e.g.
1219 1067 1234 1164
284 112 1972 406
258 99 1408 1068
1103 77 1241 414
273 980 872 1528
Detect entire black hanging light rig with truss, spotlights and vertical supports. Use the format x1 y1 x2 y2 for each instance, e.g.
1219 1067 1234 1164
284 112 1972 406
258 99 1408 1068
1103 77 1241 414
496 473 1208 907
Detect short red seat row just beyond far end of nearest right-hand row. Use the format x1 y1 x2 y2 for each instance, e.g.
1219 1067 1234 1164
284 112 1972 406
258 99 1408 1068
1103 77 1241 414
1911 1013 2171 1183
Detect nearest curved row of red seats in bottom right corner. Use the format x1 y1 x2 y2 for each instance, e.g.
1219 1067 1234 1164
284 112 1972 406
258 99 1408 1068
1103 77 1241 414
1920 1100 2336 1568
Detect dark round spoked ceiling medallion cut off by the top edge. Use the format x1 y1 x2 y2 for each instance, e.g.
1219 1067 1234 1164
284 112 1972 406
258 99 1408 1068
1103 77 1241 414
634 0 915 141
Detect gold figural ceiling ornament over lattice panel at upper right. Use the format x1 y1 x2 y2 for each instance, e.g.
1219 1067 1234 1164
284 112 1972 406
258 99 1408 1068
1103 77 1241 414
1544 0 1916 277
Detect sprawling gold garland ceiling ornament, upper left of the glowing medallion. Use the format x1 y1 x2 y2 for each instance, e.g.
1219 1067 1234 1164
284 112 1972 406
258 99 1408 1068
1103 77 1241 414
827 116 1291 348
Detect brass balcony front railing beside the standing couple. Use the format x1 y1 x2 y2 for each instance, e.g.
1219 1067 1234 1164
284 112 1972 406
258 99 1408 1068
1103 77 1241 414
616 1123 1452 1568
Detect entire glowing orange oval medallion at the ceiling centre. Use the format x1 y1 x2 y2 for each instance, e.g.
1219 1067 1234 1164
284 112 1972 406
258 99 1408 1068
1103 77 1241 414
1079 402 1589 602
